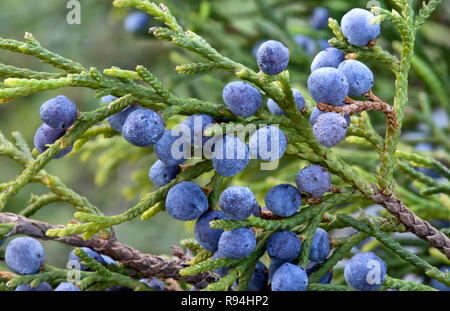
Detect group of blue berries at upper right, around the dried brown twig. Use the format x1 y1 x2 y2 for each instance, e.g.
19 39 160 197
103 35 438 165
308 9 380 147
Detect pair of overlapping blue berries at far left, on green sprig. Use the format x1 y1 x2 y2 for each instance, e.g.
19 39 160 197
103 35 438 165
34 95 78 159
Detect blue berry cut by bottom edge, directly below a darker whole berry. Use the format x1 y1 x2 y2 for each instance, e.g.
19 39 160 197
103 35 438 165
272 263 308 291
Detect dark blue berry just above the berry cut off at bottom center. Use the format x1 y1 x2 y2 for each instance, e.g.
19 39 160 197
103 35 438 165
266 231 302 262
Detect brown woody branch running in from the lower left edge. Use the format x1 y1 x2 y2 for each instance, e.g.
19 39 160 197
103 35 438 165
0 213 218 288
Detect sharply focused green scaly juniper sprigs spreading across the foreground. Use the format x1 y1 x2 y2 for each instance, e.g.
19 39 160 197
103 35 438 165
0 0 444 290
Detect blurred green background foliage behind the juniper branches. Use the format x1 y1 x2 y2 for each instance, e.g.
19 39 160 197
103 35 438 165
0 0 450 282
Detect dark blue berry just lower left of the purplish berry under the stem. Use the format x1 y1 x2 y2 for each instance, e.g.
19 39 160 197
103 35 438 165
264 184 302 217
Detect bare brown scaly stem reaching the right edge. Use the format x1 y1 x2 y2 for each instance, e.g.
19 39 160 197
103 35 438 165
371 185 450 259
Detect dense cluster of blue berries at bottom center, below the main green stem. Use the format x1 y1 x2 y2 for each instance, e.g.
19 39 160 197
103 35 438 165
187 165 338 291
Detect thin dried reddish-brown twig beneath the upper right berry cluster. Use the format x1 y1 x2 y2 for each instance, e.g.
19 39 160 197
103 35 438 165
317 91 398 129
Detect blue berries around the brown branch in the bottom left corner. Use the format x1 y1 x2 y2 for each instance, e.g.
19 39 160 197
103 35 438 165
5 237 164 291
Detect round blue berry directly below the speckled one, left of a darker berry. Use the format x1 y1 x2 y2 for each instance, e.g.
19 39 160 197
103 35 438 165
218 227 256 259
